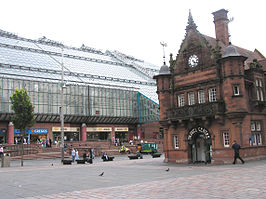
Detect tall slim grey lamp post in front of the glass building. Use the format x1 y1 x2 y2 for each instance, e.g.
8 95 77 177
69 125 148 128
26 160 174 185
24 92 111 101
60 47 65 162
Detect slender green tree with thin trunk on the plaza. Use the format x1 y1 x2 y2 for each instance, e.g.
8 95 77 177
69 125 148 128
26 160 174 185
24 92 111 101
10 89 35 166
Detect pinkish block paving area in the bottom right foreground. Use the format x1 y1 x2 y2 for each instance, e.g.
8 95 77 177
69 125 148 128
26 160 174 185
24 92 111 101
21 165 266 199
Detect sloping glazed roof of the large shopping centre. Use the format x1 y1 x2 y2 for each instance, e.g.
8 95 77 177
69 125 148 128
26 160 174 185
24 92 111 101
0 33 158 102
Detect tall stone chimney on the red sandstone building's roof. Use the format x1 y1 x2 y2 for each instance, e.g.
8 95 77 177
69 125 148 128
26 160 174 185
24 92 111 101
212 9 229 46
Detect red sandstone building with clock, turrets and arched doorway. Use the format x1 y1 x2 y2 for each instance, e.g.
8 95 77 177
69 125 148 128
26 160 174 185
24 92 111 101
154 9 266 163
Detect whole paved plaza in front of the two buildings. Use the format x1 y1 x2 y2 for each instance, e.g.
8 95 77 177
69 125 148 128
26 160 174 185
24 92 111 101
0 155 266 199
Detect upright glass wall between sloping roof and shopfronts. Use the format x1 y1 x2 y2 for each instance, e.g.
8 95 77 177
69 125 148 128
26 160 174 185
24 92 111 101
0 77 159 123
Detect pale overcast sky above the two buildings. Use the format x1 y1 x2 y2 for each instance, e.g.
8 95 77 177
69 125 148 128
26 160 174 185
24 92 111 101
0 0 266 66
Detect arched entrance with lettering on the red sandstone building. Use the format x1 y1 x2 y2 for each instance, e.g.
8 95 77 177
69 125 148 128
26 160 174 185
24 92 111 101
187 126 212 163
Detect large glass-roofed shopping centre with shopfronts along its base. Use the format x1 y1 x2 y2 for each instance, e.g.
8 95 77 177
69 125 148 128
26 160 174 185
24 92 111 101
0 30 159 144
